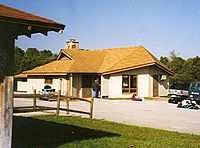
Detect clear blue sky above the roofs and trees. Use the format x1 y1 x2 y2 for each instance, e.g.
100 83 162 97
0 0 200 58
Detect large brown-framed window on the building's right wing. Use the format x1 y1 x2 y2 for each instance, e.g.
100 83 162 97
122 75 137 95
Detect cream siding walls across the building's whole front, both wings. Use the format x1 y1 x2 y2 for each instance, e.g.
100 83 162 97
18 66 169 98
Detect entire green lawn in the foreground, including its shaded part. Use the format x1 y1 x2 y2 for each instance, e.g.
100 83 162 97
12 116 200 148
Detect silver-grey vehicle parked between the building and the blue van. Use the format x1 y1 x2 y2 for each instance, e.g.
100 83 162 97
168 83 190 103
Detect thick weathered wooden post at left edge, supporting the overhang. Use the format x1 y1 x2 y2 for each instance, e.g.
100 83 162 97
0 29 15 148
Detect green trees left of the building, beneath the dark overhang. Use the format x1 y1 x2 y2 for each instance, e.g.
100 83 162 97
15 46 57 74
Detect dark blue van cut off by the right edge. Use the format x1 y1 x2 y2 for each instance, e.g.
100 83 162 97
189 82 200 104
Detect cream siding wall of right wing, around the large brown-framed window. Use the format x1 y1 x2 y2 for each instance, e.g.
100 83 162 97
107 66 169 98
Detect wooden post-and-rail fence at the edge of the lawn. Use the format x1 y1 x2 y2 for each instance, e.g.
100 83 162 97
14 89 94 118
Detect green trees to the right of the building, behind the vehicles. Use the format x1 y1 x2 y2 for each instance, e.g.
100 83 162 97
160 50 200 85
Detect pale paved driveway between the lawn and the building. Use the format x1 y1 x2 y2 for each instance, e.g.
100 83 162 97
14 99 200 135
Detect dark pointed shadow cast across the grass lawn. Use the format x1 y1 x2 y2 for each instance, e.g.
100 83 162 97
12 116 120 148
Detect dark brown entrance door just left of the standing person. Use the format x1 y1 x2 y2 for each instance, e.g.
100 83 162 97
82 75 93 98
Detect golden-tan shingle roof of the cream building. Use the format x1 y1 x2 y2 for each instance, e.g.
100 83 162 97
19 46 173 75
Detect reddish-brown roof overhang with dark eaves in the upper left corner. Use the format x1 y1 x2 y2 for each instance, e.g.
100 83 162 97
0 4 65 38
